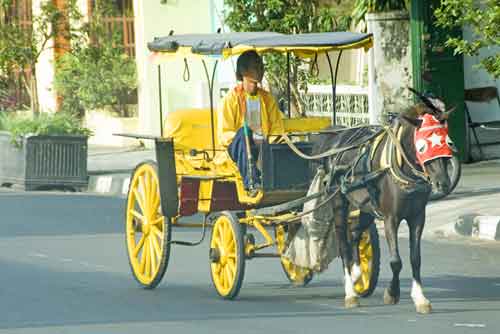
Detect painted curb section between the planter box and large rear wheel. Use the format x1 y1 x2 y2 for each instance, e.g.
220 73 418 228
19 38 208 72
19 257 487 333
87 170 130 196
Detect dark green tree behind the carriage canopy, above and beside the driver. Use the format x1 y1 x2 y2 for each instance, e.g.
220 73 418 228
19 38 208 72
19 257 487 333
224 0 351 115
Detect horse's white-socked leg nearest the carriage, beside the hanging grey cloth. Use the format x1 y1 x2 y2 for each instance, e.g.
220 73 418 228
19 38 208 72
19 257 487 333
334 196 359 308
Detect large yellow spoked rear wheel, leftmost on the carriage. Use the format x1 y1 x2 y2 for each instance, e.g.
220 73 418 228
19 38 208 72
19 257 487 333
125 161 171 289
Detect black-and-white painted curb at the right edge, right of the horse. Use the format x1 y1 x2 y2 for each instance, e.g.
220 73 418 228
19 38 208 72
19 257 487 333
454 213 500 241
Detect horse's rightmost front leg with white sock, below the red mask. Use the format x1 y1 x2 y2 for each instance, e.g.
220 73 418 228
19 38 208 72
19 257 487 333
408 210 432 314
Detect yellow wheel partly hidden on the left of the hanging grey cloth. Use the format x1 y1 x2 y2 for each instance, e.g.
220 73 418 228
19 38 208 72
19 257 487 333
274 225 314 286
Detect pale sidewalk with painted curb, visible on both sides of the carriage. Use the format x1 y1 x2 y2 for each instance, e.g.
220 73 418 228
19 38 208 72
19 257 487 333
88 146 500 239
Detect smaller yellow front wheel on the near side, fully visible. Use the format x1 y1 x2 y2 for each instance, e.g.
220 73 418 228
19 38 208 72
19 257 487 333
209 211 245 299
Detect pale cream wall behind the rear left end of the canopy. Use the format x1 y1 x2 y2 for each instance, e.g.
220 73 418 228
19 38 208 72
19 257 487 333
134 0 216 135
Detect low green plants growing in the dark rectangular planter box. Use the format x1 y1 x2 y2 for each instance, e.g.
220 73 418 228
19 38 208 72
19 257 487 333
0 112 92 142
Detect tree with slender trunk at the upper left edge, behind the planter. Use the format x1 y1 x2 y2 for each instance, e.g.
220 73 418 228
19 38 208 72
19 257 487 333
0 0 81 114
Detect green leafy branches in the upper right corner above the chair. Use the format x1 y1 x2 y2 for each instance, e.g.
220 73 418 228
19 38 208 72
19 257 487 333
434 0 500 78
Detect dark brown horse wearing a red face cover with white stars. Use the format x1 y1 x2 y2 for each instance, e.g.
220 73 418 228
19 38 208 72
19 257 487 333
313 90 452 313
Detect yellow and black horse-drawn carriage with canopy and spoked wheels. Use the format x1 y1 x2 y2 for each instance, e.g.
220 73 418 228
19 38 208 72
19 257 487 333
122 32 380 299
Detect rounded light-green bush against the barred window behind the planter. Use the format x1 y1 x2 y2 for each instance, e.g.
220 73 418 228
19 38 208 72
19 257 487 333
55 4 137 114
